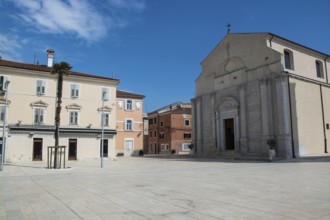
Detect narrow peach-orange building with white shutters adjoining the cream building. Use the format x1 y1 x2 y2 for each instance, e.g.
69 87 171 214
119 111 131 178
116 90 144 156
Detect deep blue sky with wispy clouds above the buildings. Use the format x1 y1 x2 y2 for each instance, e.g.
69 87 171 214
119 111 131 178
0 0 330 112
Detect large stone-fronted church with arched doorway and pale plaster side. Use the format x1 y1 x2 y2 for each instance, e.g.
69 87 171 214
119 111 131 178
192 33 330 158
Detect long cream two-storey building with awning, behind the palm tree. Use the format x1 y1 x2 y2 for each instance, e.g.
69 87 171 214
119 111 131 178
0 51 119 162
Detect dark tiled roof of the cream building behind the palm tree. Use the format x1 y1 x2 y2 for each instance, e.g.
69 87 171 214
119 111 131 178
0 59 119 82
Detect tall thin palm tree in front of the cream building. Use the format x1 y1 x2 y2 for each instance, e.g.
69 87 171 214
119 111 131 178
51 62 72 169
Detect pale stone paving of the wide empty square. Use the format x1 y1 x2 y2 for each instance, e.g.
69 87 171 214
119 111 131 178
0 157 330 220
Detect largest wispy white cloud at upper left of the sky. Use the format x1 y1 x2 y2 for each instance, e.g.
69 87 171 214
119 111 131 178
12 0 146 42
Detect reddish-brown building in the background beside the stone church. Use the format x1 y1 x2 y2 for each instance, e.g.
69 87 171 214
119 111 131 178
148 102 192 154
